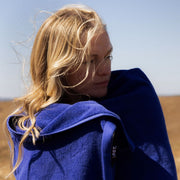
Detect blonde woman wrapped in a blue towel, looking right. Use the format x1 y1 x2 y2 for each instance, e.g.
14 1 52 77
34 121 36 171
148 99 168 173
7 3 176 180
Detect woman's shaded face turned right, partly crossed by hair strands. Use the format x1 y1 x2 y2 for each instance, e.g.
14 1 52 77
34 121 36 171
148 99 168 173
66 31 112 98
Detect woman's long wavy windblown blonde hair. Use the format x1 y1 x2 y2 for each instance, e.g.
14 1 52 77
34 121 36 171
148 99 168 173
5 5 105 176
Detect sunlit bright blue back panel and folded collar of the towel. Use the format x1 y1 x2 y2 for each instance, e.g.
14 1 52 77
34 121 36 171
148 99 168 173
8 101 133 180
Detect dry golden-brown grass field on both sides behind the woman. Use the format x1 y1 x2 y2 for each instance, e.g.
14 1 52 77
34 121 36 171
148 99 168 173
0 96 180 180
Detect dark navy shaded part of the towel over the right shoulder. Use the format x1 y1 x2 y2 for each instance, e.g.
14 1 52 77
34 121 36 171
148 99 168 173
99 69 177 180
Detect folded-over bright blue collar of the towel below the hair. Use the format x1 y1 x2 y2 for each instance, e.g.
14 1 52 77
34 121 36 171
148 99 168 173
7 100 119 136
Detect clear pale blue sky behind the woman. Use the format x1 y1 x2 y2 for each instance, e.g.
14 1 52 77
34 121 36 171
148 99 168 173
0 0 180 98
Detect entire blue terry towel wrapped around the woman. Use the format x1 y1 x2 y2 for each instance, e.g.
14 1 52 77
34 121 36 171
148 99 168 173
7 69 177 180
